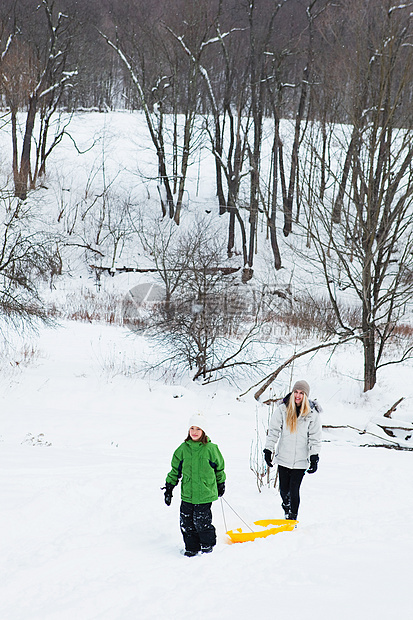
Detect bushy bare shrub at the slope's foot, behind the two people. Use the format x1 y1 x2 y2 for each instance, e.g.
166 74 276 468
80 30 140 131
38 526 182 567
130 221 271 381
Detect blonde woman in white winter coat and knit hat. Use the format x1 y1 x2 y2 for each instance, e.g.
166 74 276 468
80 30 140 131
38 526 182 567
264 381 321 520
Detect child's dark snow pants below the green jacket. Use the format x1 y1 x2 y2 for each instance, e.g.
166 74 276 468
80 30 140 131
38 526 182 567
180 502 217 551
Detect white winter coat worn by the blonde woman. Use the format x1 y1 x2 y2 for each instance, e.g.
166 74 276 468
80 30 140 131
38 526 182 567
265 401 321 469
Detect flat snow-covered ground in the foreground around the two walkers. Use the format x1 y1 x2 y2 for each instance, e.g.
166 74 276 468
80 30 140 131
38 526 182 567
0 322 413 620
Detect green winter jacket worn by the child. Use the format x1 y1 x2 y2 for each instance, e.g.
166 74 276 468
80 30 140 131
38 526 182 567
166 439 225 504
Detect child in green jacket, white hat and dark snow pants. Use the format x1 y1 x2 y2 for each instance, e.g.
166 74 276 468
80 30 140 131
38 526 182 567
164 413 225 557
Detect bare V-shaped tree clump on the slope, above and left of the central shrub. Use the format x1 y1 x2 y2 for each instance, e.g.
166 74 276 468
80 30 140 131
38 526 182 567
101 0 210 224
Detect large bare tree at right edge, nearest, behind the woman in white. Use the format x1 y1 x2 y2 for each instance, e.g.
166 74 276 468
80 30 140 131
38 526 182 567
296 1 413 391
